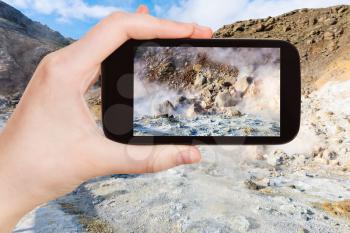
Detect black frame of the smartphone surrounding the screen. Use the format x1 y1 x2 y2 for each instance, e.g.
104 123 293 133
101 39 301 145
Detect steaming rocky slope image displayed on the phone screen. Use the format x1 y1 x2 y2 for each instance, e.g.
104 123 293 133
133 46 280 137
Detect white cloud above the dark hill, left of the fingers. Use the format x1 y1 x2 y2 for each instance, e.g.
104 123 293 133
5 0 122 22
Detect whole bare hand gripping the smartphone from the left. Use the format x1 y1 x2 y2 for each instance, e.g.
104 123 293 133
0 6 212 232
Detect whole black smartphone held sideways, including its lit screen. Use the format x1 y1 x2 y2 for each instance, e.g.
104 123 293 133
102 39 301 145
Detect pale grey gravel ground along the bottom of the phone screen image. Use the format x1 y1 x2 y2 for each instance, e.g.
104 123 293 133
134 114 280 136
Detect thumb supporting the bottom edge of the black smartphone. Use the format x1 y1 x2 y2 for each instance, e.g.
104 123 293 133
83 138 201 176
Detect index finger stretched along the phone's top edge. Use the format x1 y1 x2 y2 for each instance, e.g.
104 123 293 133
62 12 211 69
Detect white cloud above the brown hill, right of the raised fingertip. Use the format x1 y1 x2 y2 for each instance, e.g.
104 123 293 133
156 0 350 29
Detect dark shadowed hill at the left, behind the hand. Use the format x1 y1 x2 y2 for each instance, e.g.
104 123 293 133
0 1 70 95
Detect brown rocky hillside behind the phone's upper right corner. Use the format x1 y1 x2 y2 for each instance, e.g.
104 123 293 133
214 5 350 94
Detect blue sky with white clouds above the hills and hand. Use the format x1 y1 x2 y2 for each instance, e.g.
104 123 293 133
3 0 350 39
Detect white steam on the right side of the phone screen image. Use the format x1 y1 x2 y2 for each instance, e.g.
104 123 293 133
209 48 281 120
